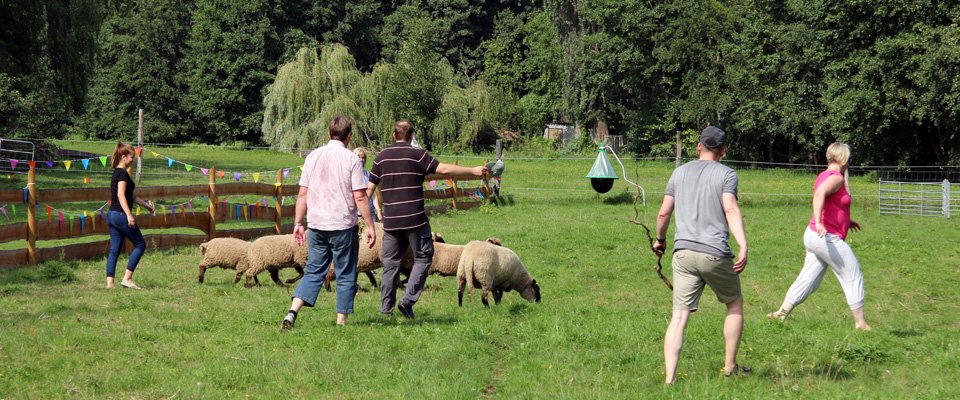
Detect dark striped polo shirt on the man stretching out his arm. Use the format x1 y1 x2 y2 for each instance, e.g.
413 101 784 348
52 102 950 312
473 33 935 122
370 142 440 231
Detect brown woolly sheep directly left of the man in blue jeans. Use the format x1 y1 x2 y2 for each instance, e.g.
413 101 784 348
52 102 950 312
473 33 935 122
244 235 308 288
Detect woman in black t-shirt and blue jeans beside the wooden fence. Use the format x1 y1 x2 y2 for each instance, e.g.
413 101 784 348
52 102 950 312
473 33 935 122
107 142 154 290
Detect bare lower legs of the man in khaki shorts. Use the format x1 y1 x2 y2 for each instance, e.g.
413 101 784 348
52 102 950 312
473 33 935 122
663 297 743 384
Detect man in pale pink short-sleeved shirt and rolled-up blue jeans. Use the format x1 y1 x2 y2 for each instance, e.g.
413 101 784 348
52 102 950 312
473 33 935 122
281 116 377 329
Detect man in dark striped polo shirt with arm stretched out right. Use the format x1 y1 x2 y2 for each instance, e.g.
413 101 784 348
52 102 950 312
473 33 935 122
367 120 487 319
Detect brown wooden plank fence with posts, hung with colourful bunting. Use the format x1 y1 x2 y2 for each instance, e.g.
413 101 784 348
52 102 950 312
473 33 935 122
0 168 491 269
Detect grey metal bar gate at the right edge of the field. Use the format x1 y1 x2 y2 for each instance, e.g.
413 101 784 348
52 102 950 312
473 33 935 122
878 179 960 218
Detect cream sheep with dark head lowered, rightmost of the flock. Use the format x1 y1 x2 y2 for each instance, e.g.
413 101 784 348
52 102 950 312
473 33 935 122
457 240 540 307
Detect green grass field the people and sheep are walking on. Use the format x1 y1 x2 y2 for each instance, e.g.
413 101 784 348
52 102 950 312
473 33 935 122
0 148 960 399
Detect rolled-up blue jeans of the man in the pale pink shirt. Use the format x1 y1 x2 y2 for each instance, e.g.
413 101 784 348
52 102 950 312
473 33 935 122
293 226 360 314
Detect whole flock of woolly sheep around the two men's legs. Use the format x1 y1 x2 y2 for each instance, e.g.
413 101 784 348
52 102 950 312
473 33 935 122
198 224 540 307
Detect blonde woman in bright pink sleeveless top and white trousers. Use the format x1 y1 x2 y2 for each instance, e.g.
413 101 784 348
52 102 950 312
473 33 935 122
767 143 870 330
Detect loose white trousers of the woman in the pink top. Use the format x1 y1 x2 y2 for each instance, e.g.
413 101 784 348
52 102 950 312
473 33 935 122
786 227 864 310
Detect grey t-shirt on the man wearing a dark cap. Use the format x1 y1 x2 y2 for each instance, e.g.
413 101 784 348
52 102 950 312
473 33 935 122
664 160 737 258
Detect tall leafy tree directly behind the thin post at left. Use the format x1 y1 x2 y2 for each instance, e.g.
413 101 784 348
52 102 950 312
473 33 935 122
74 0 194 143
